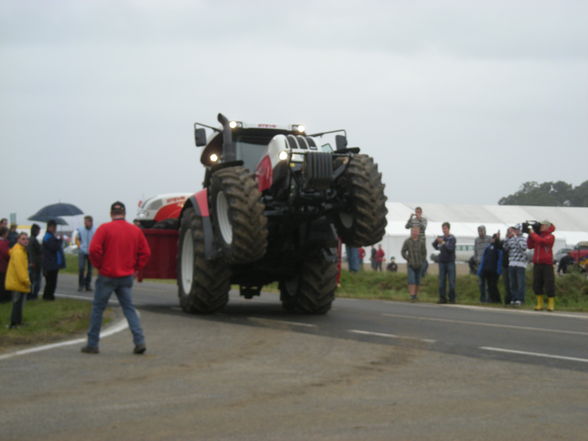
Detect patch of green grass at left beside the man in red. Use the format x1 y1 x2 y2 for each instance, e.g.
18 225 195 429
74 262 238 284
0 299 113 352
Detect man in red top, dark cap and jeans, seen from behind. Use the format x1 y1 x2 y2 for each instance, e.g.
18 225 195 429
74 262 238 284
82 202 151 354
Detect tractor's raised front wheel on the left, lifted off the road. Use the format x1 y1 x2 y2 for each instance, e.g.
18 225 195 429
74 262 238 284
209 166 268 264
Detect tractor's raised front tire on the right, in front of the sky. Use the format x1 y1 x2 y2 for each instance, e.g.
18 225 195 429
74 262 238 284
335 155 388 247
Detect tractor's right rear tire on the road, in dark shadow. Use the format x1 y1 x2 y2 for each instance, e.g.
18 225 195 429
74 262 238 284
280 252 337 314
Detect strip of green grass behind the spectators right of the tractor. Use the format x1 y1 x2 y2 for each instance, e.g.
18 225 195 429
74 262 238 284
337 271 588 311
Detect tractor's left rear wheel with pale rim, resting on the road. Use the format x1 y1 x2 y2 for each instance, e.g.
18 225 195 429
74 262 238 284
177 207 231 314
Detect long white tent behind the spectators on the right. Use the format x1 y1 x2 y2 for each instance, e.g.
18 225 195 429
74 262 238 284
376 202 588 263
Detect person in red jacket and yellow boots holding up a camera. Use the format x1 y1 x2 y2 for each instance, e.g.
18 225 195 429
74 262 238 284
527 221 555 312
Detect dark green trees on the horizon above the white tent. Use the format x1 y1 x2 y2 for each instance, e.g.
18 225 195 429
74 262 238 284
498 181 588 207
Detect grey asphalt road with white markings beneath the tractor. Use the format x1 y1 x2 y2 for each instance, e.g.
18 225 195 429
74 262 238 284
0 275 588 441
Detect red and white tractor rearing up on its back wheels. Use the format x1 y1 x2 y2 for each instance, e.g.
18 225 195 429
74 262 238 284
137 114 387 314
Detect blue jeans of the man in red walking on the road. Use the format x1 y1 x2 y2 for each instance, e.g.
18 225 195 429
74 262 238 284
88 275 145 348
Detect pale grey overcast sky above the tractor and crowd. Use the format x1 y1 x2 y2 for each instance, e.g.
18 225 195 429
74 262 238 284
0 0 588 223
